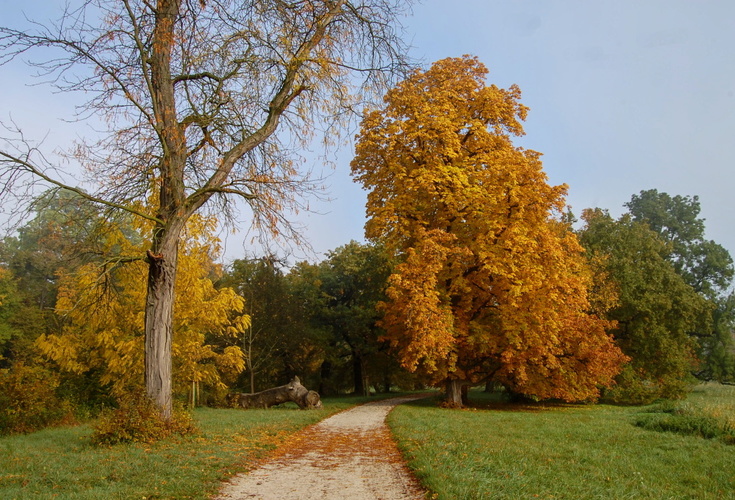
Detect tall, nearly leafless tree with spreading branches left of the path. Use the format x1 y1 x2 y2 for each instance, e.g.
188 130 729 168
0 0 404 417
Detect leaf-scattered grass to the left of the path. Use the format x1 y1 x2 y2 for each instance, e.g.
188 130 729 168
0 398 375 500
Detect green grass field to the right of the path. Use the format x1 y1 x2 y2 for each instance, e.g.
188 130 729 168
389 385 735 500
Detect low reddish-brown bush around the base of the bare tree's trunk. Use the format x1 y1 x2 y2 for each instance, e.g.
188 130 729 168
92 395 196 445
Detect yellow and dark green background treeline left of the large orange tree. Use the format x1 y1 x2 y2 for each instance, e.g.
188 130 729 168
0 191 417 431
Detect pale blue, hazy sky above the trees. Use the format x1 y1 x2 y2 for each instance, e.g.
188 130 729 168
0 0 735 266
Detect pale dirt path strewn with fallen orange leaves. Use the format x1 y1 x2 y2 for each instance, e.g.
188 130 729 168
217 396 432 500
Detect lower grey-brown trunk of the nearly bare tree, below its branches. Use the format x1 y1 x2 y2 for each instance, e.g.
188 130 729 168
145 236 178 419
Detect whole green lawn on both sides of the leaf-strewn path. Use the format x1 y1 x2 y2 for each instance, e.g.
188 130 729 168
5 386 735 500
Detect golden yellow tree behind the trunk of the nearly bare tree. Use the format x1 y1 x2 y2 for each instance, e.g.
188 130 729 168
36 215 249 400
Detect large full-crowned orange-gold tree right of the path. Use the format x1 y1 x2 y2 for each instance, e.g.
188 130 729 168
352 56 625 404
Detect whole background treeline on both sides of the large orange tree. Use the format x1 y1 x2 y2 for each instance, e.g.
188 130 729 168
0 190 735 432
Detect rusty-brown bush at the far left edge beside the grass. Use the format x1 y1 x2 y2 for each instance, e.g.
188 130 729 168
0 363 75 434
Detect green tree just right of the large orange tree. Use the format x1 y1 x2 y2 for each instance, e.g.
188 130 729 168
580 209 711 403
